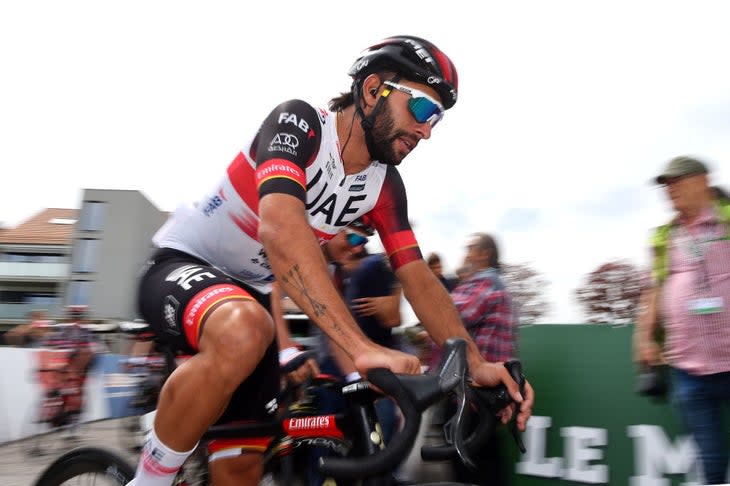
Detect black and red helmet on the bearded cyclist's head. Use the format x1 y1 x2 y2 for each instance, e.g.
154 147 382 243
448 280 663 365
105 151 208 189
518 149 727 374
347 35 459 110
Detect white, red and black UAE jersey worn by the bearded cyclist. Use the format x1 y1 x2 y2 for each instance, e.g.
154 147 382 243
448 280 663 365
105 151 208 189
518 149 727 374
153 100 420 293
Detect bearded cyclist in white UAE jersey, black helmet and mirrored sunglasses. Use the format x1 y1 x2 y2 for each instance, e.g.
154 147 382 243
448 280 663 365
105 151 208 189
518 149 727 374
133 36 533 486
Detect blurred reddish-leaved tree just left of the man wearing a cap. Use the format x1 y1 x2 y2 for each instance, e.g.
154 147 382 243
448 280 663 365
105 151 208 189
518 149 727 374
575 260 642 324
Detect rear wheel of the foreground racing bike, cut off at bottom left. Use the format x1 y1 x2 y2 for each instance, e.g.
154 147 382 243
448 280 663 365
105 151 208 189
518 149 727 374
34 447 134 486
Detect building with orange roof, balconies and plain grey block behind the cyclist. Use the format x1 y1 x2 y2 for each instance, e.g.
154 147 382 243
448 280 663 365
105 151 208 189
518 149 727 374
0 189 167 325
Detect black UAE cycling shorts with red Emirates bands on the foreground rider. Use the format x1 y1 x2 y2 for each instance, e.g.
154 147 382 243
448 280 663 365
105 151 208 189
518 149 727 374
137 248 279 423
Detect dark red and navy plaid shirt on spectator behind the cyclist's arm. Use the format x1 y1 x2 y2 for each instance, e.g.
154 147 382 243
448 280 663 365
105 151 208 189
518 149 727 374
451 268 518 362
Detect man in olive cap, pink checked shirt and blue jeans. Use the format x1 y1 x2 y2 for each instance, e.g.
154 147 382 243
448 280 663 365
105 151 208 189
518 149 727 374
634 156 730 484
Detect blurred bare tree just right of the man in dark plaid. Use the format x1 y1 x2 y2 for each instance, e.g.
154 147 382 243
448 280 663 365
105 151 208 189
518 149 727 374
502 263 550 324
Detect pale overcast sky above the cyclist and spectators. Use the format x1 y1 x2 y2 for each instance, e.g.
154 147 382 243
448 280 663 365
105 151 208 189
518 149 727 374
0 0 730 323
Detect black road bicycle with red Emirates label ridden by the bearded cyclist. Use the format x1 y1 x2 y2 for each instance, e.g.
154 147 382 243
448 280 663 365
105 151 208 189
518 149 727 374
35 339 525 486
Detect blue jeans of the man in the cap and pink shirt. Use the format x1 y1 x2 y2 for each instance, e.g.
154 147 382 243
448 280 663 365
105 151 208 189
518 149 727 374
672 368 730 484
